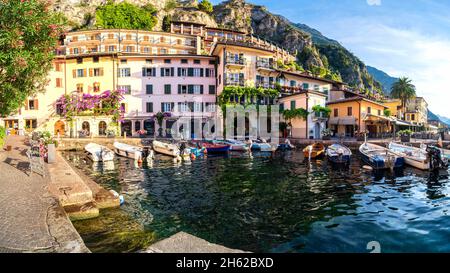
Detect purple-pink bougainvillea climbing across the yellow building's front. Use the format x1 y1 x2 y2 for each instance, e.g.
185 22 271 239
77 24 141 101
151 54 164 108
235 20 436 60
56 90 125 122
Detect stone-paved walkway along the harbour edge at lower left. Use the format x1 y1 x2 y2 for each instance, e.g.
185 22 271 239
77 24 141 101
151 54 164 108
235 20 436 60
0 136 89 252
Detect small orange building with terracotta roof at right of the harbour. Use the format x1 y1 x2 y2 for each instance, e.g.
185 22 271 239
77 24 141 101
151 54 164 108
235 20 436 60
327 96 392 137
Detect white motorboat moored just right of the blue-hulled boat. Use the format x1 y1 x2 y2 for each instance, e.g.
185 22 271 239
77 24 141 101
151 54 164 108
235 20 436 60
389 142 430 170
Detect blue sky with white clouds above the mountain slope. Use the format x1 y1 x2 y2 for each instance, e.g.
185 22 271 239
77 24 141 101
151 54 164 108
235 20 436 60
212 0 450 117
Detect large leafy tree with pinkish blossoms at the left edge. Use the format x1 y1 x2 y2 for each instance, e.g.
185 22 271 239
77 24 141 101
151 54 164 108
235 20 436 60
0 0 64 116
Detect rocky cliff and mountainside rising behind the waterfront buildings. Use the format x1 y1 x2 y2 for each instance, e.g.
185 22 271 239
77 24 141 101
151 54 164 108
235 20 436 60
53 0 381 92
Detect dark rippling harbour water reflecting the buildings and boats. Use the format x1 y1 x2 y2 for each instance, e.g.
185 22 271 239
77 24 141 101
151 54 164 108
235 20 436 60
65 152 450 253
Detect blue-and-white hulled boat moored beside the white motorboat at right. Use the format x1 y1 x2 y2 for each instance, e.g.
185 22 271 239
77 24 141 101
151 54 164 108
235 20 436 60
359 142 405 170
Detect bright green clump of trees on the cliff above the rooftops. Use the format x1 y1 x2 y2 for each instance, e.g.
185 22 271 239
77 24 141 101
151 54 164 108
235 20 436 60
95 1 157 30
